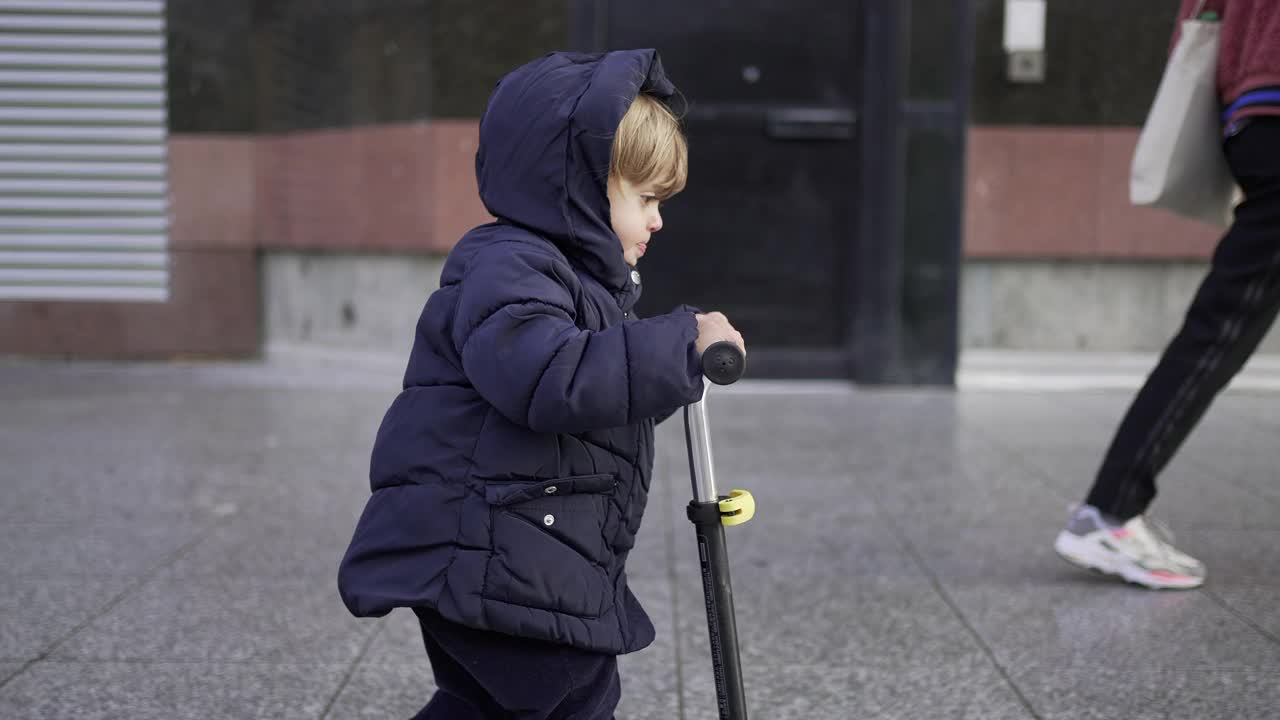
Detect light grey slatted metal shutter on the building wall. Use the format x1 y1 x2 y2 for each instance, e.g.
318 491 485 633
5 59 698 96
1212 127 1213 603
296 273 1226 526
0 0 169 301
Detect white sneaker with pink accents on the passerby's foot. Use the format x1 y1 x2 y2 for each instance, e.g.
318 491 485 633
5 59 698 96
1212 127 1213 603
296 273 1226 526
1053 505 1206 589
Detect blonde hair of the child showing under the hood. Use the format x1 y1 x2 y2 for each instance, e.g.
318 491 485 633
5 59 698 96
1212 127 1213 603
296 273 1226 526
609 92 689 200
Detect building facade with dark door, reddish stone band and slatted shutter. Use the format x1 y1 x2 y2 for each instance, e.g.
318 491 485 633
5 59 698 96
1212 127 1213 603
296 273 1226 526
0 0 1244 384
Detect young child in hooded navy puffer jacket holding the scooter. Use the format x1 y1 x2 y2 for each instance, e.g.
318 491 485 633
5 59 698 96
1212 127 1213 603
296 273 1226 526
338 50 742 720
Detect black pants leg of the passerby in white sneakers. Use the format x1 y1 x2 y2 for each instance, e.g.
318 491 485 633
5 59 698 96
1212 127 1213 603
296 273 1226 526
1087 118 1280 520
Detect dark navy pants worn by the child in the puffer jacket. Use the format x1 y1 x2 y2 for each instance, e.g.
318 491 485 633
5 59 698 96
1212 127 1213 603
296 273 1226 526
415 610 622 720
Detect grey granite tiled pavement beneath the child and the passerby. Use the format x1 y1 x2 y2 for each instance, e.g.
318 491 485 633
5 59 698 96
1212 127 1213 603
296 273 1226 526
0 364 1280 720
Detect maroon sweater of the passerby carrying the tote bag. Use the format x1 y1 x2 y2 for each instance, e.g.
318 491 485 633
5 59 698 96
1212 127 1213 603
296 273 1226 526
1174 0 1280 110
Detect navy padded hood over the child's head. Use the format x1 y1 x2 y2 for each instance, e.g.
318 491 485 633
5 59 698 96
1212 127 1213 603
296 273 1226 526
476 50 676 293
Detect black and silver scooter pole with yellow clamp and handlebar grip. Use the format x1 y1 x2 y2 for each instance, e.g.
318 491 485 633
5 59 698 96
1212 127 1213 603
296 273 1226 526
685 342 755 720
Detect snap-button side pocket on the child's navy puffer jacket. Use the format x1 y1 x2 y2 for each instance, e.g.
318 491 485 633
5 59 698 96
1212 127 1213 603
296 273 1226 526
483 474 617 618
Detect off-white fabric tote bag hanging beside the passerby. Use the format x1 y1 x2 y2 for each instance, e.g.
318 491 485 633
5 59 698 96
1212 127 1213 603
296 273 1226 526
1129 0 1236 227
